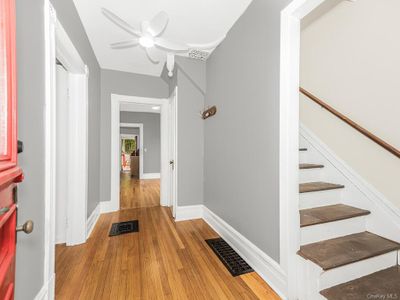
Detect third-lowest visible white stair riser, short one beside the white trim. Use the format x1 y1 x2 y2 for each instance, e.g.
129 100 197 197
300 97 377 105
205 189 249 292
299 189 342 209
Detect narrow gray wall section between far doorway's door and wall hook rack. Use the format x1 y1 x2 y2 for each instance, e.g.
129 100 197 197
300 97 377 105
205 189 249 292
176 58 206 206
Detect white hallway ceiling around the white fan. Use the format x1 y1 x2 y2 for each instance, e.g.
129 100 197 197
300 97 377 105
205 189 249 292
73 0 251 76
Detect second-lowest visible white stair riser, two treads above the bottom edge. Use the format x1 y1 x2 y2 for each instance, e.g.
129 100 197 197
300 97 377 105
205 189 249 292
300 216 366 245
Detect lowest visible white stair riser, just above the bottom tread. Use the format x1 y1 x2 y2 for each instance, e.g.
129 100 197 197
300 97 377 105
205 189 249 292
319 251 397 290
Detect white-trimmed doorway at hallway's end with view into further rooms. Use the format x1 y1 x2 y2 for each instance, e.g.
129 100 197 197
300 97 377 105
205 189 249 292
110 90 178 216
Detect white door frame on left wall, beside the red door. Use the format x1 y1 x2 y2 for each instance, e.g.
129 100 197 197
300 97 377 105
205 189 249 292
44 0 89 299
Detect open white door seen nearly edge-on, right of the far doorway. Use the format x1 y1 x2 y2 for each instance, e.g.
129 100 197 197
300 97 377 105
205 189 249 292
169 89 178 218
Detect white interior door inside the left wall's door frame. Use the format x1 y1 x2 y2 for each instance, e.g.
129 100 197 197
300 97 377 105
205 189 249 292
55 65 68 244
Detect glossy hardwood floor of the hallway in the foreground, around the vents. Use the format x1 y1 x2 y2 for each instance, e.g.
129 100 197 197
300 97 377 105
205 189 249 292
56 206 279 300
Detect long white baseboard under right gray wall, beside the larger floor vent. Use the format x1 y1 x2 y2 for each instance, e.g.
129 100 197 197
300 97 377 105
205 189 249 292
203 206 287 299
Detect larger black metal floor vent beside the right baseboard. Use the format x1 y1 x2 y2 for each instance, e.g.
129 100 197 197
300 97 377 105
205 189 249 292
206 238 254 276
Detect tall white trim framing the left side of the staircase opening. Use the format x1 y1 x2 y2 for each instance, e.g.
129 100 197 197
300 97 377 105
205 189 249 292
279 0 325 299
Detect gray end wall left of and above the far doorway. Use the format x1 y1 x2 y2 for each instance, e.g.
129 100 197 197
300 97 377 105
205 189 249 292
100 70 169 201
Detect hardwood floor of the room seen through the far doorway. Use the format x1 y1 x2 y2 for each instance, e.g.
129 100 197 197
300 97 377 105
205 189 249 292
120 173 160 209
